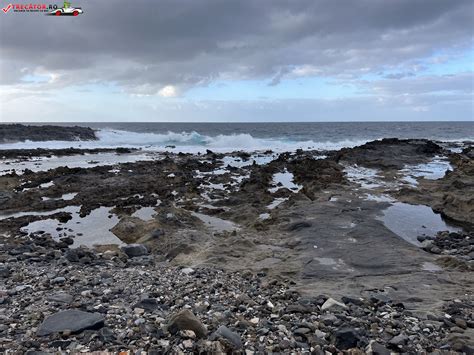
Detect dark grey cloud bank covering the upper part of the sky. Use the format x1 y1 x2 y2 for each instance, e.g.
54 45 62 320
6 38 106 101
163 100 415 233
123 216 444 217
0 0 474 94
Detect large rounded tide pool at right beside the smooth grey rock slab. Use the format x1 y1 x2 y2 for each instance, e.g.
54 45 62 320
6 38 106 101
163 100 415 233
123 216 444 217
379 202 461 246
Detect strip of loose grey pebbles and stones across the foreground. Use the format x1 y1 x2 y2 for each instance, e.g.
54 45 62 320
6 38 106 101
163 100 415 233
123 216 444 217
0 237 474 354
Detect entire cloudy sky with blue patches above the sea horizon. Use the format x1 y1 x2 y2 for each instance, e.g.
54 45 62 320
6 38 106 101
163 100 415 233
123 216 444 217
0 0 474 122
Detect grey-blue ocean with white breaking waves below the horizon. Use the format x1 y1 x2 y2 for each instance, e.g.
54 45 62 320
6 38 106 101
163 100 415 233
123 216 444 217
0 122 474 152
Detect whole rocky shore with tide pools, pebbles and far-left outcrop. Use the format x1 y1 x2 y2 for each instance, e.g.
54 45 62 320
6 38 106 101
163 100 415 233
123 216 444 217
0 125 474 354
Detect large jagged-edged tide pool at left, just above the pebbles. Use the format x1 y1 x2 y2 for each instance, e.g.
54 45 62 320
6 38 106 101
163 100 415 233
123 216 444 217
21 206 124 248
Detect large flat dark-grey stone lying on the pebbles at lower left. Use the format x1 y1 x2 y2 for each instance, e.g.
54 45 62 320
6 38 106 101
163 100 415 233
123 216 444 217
37 309 105 336
